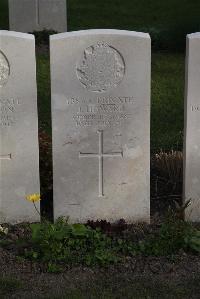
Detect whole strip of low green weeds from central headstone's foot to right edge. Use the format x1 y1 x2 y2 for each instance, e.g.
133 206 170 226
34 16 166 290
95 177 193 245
19 216 200 272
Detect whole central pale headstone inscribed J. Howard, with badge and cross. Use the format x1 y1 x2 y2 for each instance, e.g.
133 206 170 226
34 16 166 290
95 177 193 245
51 30 151 222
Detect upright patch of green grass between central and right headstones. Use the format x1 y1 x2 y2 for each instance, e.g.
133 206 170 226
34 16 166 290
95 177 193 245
151 53 184 150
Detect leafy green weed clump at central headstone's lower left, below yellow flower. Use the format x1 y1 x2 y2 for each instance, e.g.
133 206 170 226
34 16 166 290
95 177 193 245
26 219 122 272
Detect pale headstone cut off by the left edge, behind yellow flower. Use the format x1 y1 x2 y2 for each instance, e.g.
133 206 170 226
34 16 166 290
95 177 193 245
0 31 40 223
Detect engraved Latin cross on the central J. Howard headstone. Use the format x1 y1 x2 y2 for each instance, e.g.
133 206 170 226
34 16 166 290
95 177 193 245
79 130 123 197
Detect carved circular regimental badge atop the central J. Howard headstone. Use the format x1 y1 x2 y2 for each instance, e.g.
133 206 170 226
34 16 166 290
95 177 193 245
76 42 125 92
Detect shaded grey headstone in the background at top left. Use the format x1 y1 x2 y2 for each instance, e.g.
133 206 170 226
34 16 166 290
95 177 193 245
9 0 67 32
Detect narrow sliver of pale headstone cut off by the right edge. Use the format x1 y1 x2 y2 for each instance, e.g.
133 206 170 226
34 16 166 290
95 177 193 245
184 33 200 222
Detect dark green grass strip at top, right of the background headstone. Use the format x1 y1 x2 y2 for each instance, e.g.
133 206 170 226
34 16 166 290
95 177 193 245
67 0 200 30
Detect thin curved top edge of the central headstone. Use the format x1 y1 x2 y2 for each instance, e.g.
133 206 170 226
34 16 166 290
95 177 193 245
50 29 150 40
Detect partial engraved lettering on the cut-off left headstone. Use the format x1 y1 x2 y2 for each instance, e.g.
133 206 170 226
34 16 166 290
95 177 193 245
0 98 21 127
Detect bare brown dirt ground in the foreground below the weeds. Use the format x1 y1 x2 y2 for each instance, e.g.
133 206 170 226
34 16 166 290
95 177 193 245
0 244 200 299
